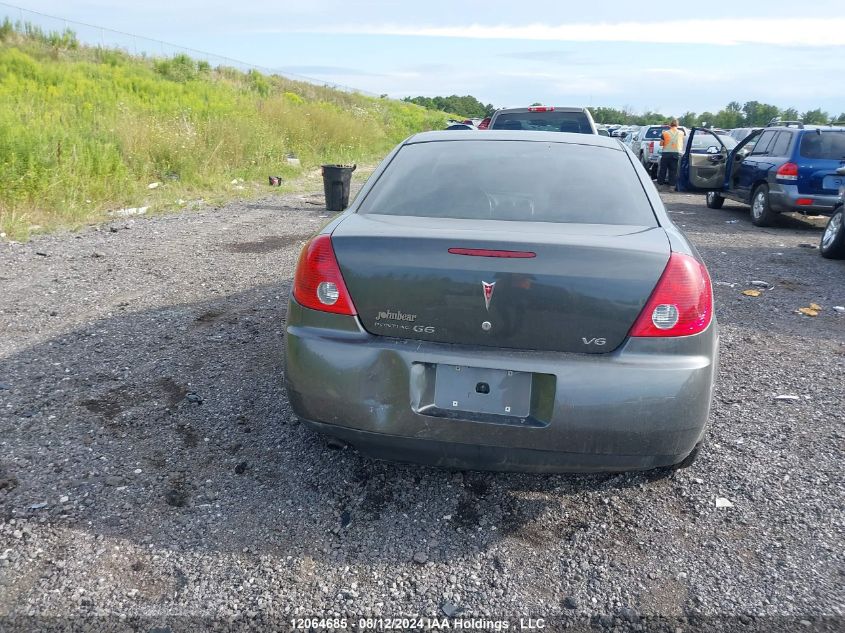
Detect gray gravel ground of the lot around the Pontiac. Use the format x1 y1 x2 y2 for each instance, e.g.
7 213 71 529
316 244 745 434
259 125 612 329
0 184 845 633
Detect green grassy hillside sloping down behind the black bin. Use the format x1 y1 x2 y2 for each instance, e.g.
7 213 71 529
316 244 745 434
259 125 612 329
0 22 446 239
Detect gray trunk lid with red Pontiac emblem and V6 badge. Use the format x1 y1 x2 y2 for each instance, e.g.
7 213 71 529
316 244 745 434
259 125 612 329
332 214 670 353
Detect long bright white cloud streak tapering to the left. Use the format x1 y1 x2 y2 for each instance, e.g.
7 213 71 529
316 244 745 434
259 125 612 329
294 18 845 47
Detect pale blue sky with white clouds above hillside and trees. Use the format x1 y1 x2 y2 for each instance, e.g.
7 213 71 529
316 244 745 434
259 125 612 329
6 0 845 115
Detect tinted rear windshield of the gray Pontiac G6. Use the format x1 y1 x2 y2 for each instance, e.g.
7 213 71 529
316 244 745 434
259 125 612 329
359 141 657 226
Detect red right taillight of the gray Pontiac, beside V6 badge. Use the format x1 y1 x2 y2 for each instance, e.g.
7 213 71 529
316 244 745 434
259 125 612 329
630 253 713 336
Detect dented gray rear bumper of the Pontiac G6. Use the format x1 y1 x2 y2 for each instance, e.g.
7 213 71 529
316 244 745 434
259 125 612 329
286 301 718 472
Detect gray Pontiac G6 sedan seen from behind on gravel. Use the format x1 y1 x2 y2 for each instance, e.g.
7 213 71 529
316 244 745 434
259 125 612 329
285 131 718 472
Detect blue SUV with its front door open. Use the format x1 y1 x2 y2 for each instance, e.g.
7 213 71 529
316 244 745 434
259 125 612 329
678 125 845 226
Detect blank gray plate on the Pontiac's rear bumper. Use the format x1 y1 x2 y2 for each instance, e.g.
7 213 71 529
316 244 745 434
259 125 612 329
434 365 532 418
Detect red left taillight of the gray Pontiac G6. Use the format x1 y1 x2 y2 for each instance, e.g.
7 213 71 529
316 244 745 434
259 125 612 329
293 235 356 316
